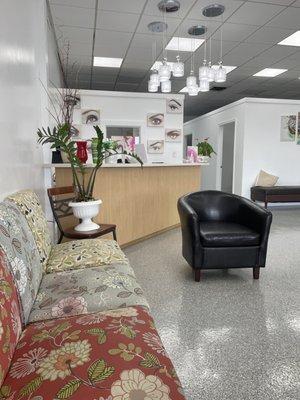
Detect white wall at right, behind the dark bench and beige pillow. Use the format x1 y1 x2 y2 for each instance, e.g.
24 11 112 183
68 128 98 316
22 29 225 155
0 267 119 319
242 99 300 197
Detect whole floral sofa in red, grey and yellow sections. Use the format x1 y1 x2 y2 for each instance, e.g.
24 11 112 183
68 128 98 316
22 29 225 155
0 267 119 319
0 191 184 400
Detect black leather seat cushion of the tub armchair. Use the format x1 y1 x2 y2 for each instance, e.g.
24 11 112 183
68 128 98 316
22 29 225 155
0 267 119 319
200 221 260 247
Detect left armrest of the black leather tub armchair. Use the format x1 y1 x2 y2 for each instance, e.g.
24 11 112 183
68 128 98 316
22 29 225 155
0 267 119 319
177 197 202 268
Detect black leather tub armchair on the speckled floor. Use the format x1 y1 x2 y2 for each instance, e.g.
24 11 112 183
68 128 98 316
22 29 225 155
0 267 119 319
177 190 272 282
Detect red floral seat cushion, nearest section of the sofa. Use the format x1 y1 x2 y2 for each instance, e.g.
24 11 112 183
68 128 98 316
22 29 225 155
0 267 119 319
2 307 184 400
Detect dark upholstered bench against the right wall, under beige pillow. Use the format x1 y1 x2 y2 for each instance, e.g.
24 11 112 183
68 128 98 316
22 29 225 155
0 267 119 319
251 186 300 208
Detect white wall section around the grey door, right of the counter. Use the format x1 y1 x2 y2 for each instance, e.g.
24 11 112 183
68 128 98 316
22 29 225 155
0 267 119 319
183 101 245 194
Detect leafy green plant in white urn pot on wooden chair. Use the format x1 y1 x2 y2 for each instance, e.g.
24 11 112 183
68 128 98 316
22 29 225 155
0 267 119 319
37 124 143 232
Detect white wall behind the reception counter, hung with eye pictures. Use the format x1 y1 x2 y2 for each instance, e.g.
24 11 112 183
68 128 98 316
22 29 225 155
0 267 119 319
74 90 184 163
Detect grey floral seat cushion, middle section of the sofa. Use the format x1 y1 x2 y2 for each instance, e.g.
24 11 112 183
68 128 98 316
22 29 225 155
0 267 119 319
29 264 148 322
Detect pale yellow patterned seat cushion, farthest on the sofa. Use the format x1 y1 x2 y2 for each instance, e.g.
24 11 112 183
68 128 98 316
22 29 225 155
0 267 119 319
46 239 128 273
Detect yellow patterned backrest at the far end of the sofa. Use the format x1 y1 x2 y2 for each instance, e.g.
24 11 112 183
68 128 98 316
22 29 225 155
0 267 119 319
6 190 52 269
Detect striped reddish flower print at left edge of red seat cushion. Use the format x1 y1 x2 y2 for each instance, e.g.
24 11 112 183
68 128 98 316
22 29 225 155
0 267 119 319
9 347 47 379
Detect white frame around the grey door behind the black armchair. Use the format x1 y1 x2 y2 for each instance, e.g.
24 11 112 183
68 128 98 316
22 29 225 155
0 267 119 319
216 118 237 193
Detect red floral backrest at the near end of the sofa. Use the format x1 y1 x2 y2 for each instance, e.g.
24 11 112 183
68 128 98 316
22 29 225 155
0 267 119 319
0 249 21 387
